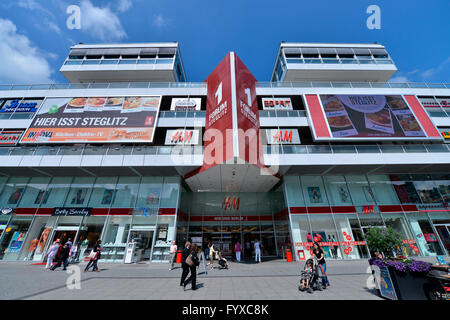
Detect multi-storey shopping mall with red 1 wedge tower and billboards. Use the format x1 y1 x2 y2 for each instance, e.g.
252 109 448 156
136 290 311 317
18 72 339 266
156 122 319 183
0 42 450 263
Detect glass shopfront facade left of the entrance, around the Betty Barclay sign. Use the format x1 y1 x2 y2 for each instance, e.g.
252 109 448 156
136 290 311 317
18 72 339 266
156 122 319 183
0 177 180 262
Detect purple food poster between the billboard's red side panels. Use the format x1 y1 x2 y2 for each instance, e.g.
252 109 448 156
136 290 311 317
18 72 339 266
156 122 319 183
320 95 426 138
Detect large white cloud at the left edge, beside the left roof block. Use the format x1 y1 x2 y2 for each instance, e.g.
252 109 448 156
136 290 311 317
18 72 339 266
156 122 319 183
0 18 52 84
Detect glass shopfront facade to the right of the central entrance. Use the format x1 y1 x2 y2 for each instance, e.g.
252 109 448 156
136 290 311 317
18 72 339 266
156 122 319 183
283 175 450 259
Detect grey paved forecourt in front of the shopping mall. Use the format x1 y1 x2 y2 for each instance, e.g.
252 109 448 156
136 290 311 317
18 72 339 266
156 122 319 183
0 260 386 300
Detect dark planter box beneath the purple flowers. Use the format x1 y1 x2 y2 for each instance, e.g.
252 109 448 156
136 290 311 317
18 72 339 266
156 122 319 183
388 267 428 300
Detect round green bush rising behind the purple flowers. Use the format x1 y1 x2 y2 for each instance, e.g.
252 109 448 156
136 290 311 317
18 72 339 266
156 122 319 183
365 227 402 254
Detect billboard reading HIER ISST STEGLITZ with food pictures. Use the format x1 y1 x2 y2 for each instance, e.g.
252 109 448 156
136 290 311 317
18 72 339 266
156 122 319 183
21 96 161 143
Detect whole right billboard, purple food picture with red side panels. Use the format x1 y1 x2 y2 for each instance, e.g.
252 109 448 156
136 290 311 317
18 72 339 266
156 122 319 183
306 95 442 140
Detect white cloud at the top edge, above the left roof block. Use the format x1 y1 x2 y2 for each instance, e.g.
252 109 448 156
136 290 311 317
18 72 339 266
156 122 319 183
81 0 127 41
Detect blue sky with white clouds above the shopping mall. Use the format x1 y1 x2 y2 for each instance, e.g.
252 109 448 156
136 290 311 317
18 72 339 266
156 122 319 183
0 0 450 84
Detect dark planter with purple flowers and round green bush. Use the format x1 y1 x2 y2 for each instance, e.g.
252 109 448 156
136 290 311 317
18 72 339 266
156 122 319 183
366 228 431 300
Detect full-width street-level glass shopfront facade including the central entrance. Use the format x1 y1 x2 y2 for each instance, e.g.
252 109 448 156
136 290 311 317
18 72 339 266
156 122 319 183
0 175 450 262
